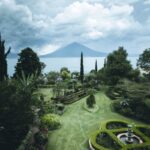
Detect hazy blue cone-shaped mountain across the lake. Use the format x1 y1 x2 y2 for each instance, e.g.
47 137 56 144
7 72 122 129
41 42 107 57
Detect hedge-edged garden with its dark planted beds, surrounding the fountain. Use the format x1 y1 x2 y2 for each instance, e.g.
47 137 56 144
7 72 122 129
90 119 150 150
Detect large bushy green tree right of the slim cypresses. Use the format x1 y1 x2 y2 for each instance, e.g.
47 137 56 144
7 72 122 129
103 47 132 84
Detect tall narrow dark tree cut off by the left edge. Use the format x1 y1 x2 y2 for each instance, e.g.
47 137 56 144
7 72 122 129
0 35 11 81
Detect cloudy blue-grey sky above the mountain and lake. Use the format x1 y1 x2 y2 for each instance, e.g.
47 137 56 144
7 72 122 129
0 0 150 55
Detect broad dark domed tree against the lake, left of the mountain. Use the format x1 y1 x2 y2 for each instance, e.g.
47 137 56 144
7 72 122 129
14 48 43 77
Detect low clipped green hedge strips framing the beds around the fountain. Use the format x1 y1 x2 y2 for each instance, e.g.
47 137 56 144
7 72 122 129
89 120 150 150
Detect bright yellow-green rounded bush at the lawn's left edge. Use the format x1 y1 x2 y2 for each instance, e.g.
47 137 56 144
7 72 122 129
41 114 60 130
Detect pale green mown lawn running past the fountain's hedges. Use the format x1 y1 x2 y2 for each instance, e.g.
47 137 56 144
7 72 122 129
45 92 145 150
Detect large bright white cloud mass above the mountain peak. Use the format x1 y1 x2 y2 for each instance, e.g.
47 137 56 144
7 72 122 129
52 2 137 40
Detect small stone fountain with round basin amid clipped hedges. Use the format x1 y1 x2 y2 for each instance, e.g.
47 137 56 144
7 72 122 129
117 125 143 144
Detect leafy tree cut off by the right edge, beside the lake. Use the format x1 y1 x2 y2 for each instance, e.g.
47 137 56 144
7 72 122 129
137 48 150 73
